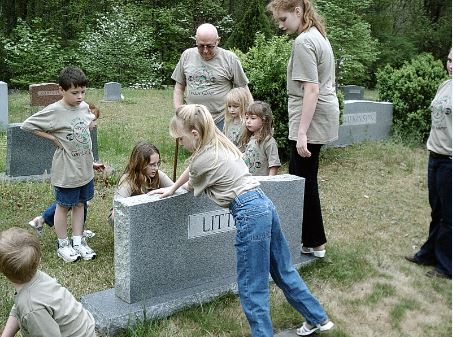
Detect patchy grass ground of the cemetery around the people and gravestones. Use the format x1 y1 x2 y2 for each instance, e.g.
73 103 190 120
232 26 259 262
0 89 452 337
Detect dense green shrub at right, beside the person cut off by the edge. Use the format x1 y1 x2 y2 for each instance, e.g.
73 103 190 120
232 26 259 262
377 54 446 143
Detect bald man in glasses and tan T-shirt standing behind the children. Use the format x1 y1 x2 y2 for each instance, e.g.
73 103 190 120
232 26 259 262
171 23 250 130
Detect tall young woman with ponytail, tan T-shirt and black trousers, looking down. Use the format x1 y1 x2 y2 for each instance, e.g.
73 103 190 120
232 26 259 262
267 0 339 257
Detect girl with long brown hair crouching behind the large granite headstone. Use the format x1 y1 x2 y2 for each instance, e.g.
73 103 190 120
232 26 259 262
109 141 173 224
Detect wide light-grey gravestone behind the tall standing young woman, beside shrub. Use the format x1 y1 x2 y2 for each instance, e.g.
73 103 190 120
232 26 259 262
328 101 393 146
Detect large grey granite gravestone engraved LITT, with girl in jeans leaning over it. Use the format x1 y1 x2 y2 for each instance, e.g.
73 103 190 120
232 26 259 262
82 174 312 334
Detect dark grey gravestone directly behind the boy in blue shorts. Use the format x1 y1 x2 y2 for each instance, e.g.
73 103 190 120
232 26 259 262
6 123 99 179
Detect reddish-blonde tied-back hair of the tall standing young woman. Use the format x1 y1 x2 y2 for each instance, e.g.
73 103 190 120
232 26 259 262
266 0 326 37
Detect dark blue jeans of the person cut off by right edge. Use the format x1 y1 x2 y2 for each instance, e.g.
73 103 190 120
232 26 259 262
415 153 452 277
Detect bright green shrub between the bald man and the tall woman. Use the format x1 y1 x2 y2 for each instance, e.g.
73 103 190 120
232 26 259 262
236 33 291 158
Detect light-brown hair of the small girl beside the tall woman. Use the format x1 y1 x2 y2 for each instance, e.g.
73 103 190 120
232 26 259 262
239 101 273 148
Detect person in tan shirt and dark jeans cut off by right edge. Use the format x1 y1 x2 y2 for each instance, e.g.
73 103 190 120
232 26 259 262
406 49 452 279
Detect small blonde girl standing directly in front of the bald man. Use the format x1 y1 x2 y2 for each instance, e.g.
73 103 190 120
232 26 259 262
223 87 253 145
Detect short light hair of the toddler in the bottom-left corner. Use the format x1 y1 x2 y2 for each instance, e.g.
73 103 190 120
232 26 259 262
0 227 41 284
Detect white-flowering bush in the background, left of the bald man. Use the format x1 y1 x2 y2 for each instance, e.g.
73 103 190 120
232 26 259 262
80 7 162 88
